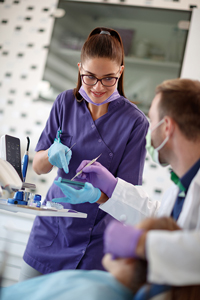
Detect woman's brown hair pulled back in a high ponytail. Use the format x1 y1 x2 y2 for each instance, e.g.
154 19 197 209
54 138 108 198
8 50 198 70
74 27 125 100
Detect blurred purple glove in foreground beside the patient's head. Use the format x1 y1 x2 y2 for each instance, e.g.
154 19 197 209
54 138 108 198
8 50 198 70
104 221 144 259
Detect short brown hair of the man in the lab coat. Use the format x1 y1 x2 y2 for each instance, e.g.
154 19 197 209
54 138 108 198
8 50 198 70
156 79 200 141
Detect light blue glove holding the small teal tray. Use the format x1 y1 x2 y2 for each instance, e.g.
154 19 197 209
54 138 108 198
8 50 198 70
52 177 101 204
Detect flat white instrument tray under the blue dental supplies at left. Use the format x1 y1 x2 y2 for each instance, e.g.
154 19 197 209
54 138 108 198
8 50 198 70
0 199 87 218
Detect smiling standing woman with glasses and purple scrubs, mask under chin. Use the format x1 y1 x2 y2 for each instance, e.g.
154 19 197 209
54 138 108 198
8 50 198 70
20 28 148 280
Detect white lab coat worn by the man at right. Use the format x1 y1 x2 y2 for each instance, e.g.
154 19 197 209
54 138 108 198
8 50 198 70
100 170 200 285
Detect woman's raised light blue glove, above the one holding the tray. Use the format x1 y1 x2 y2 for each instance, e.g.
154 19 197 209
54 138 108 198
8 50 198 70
48 139 72 173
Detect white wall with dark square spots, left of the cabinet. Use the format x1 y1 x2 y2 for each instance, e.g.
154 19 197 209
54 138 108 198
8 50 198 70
0 0 58 194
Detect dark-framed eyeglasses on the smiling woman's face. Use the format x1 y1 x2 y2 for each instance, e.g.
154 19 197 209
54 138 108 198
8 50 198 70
81 67 121 87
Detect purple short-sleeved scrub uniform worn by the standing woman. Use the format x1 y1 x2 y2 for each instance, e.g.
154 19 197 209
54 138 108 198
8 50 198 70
23 90 148 274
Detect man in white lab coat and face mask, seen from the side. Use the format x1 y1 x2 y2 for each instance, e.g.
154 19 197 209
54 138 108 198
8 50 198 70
72 79 200 285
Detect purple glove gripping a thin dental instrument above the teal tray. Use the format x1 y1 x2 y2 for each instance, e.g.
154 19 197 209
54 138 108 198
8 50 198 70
76 160 117 198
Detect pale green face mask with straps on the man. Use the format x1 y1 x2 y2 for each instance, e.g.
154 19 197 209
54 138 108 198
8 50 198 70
146 119 169 167
